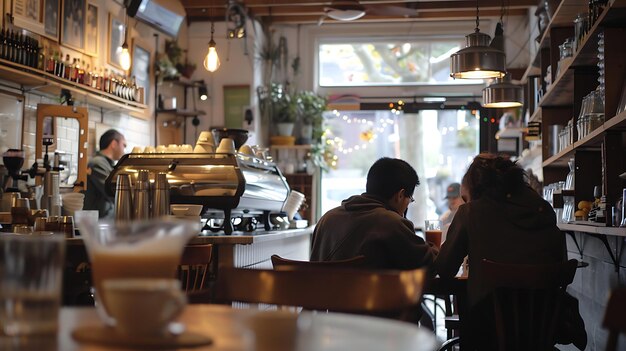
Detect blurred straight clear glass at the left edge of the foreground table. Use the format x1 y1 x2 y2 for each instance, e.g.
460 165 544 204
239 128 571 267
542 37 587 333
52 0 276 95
0 232 65 338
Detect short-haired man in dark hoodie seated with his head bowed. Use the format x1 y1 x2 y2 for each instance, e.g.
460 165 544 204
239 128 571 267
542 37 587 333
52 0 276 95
311 158 437 269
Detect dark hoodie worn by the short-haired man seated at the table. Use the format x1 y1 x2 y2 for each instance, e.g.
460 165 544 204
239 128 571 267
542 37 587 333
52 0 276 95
311 193 437 269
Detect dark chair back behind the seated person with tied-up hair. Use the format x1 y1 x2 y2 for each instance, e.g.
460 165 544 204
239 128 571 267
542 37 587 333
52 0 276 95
470 259 578 351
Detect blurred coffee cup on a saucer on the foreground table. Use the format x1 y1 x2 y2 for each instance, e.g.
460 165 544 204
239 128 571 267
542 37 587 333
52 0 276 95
103 278 187 336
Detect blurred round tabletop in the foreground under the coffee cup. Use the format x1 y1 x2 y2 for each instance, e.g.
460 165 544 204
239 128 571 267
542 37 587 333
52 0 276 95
0 305 438 351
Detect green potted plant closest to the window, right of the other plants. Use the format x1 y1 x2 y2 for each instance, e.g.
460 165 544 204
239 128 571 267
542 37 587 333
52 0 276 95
297 91 326 144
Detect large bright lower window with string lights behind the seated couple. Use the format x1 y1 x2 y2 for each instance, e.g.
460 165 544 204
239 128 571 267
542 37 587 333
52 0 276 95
321 109 479 226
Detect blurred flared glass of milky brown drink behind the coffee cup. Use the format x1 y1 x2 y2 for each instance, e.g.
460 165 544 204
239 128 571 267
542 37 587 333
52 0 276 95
76 214 201 326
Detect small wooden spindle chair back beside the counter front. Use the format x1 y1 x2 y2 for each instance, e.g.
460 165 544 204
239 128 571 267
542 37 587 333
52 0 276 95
178 244 213 294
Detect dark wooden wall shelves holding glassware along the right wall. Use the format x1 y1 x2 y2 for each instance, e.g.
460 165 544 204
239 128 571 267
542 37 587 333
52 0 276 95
526 0 626 226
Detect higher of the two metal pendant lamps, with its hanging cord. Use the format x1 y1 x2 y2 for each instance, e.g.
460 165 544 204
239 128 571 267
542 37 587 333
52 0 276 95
450 0 506 79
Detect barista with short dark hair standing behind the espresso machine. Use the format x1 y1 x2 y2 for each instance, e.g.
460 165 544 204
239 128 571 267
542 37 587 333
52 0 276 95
83 129 126 218
